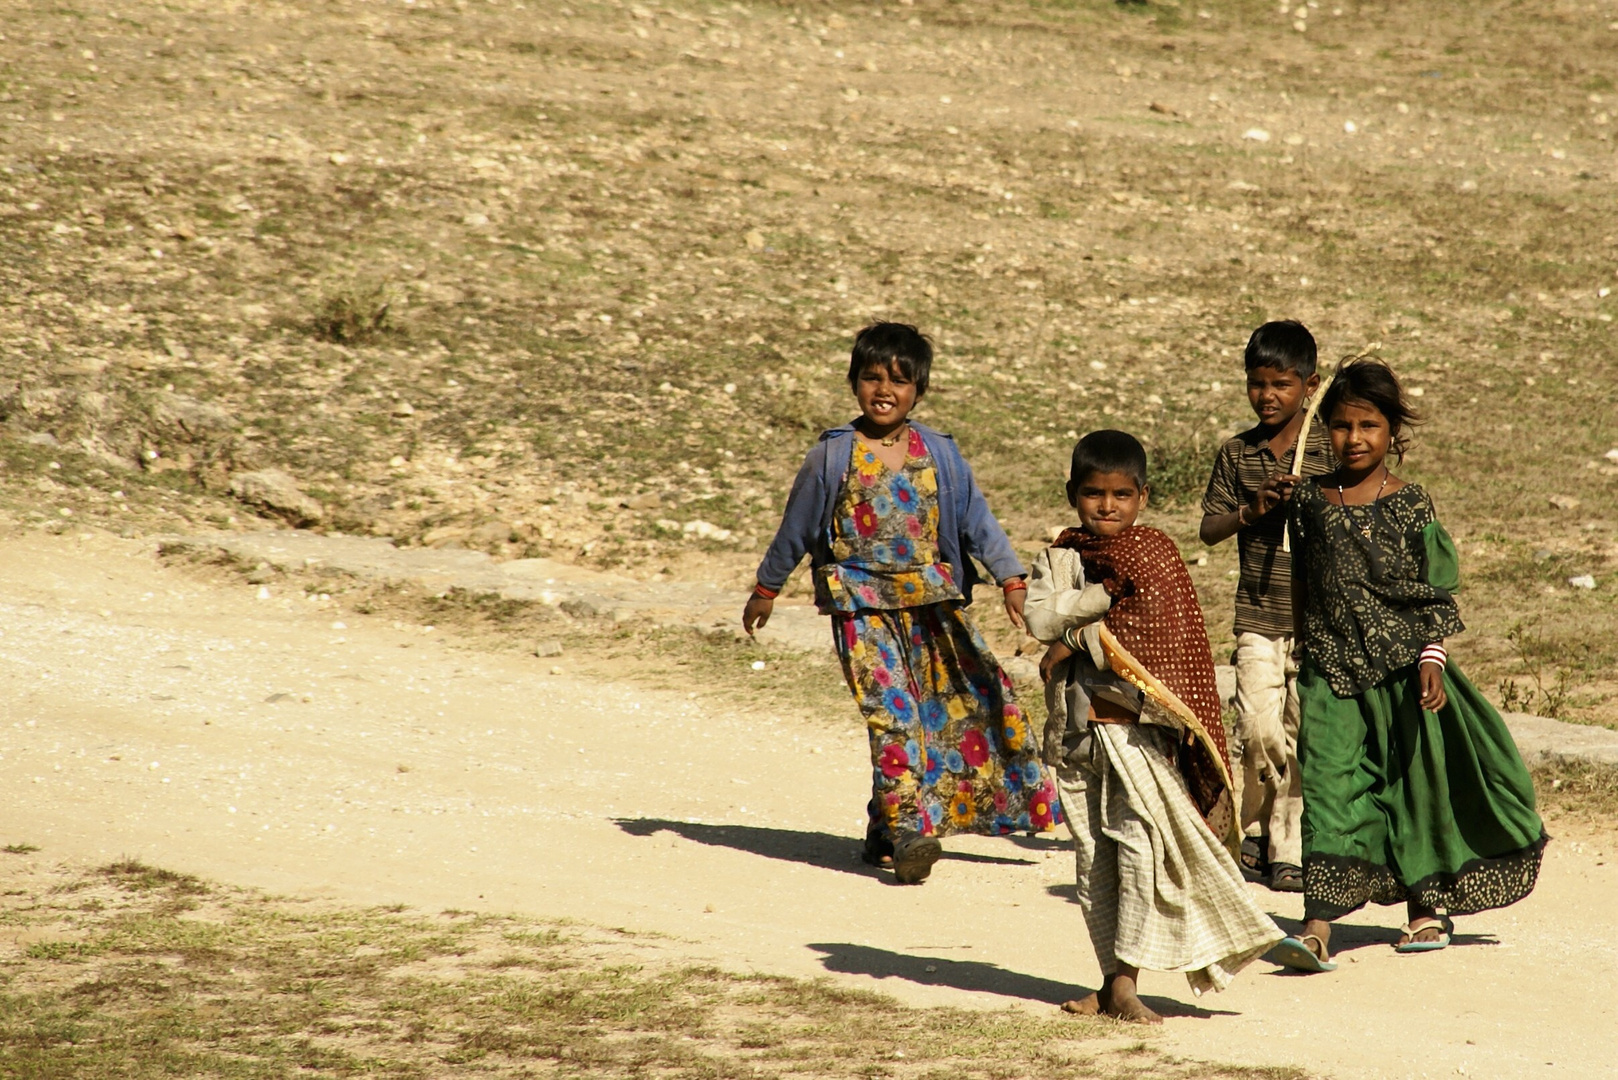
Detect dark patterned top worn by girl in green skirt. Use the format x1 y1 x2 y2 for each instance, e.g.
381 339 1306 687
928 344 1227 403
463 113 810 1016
1288 481 1466 698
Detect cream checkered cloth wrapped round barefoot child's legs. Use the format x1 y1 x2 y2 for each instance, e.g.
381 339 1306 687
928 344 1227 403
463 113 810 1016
1057 724 1285 994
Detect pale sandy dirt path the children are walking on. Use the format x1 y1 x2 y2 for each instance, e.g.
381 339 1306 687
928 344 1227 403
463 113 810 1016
0 534 1618 1078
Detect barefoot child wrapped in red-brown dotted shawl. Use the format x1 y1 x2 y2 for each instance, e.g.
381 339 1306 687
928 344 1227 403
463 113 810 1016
1026 431 1283 1023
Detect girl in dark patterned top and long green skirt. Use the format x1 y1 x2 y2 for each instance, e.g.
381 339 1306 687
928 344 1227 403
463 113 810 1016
1277 358 1547 972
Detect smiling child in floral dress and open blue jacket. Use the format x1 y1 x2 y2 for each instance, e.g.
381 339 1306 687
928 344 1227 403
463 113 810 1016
741 322 1061 884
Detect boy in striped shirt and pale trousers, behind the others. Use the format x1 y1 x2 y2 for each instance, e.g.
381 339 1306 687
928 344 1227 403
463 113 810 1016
1201 321 1332 892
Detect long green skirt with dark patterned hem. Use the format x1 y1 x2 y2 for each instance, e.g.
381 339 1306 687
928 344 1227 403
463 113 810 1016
1298 662 1547 920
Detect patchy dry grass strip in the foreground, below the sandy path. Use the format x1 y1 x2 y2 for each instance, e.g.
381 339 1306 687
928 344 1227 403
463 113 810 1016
0 860 1304 1080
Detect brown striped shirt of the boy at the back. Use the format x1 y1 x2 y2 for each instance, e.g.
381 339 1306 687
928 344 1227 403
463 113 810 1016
1202 421 1336 638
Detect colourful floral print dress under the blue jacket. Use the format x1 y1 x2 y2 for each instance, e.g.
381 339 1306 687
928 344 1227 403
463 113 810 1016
815 431 1061 837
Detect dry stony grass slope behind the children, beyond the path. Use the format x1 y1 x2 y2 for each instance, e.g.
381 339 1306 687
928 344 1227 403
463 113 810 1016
0 0 1618 722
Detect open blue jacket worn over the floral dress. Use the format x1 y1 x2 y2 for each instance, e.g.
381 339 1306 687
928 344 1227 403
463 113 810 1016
759 421 1027 604
